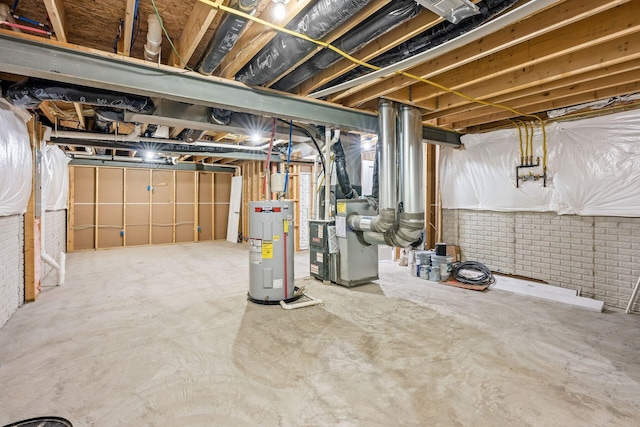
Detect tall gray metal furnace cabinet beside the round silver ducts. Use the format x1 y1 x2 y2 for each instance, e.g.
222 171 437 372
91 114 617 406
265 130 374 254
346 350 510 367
335 199 378 287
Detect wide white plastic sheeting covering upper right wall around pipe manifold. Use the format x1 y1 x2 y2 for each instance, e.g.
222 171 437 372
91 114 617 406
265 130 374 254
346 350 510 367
440 111 640 217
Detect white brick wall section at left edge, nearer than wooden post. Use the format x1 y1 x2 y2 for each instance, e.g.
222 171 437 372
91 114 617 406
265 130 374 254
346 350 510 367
0 215 24 327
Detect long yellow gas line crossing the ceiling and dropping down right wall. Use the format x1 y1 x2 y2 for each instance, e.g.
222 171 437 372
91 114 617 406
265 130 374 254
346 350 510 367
194 0 547 174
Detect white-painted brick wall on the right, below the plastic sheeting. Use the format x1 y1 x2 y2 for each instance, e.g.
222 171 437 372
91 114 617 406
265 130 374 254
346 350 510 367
442 209 640 311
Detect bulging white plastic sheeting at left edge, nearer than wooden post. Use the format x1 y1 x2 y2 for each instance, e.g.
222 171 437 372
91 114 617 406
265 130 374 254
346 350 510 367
0 102 33 216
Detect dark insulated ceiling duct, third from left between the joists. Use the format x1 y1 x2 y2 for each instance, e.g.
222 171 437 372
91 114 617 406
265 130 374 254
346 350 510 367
274 0 422 91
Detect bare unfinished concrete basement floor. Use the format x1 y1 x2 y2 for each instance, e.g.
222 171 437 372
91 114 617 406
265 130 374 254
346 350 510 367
0 242 640 426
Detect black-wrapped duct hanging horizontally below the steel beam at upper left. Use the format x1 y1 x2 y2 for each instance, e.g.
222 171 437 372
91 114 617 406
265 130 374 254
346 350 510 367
5 78 155 114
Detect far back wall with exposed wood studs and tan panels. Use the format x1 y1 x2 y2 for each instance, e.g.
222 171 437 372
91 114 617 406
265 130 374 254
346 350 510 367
67 166 232 251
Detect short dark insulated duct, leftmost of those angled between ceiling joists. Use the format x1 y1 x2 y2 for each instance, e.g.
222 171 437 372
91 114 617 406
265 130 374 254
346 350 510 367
198 0 258 75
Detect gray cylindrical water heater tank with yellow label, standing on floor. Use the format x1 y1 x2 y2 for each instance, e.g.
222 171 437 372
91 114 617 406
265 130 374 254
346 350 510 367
249 200 296 304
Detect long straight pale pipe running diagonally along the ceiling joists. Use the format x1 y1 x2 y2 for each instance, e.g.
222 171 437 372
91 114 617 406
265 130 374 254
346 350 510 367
307 0 558 98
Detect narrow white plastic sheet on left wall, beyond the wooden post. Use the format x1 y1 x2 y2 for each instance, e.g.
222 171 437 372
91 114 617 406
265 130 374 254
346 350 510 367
42 145 71 211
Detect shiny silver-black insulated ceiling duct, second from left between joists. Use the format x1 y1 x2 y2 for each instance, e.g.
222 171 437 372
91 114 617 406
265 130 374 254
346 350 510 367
236 0 371 86
